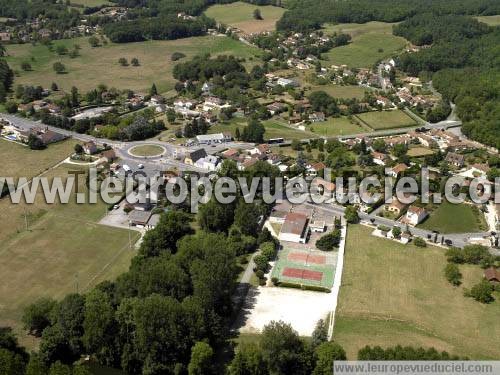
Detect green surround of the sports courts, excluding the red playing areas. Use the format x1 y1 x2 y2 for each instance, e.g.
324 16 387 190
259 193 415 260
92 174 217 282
271 247 337 288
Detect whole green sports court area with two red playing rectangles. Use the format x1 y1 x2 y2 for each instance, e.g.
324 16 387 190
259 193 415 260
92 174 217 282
271 247 337 288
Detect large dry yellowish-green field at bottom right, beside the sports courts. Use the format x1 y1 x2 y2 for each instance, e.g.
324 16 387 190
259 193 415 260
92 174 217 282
334 225 500 359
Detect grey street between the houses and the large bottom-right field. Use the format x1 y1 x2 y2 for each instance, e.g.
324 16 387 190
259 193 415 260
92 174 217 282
300 201 496 253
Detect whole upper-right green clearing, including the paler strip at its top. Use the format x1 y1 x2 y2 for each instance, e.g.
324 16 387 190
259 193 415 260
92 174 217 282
324 22 406 68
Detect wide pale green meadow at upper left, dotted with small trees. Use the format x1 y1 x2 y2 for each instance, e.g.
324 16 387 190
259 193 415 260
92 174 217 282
7 36 259 93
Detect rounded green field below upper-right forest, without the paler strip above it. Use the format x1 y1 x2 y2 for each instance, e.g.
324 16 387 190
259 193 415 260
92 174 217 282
324 32 406 68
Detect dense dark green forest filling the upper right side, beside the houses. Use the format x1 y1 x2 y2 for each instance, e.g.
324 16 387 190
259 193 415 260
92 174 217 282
394 14 500 148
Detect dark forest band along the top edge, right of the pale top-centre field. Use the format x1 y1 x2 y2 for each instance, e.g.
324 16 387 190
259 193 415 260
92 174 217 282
277 0 500 31
